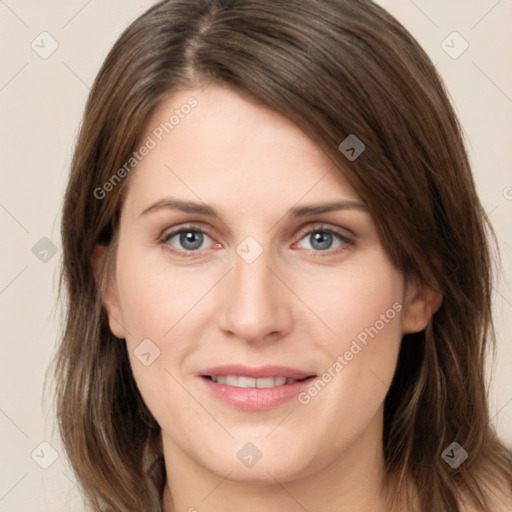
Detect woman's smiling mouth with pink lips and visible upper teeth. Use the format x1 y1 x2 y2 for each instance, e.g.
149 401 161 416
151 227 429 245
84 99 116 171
198 365 317 411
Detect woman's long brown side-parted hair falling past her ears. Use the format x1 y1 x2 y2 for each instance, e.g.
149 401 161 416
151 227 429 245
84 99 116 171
56 0 512 512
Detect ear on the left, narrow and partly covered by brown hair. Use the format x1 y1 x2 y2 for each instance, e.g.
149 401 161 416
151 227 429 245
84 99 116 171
91 245 126 339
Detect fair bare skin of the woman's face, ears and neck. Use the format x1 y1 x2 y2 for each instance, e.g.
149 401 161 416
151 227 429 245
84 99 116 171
96 85 441 512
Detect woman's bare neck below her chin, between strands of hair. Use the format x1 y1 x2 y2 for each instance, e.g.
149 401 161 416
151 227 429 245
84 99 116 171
162 413 414 512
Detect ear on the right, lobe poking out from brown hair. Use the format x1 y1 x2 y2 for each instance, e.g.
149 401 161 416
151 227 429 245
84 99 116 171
402 277 443 334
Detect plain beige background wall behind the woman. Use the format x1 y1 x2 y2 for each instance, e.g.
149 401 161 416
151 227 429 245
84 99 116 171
0 0 512 512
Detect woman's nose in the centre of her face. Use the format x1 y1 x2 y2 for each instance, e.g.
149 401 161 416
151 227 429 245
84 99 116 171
217 247 293 343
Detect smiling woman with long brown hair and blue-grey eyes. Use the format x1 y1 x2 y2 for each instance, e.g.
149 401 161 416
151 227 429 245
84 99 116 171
53 0 512 512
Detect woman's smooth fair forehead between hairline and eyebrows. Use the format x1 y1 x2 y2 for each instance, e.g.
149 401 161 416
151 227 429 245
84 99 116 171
122 85 359 218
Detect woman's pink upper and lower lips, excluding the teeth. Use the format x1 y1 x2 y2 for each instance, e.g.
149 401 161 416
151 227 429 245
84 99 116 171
199 365 316 411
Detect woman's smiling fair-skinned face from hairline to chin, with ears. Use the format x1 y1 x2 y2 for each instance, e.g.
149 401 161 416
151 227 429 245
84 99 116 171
100 85 436 481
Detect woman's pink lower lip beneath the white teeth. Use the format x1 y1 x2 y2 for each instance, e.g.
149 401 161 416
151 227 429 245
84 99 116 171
200 377 316 411
